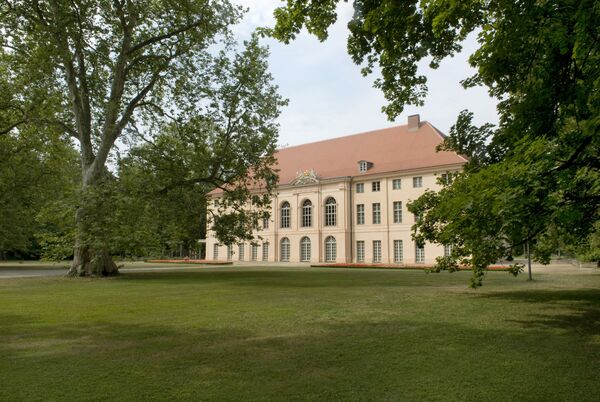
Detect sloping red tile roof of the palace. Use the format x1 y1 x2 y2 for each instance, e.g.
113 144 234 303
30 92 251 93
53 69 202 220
275 122 466 184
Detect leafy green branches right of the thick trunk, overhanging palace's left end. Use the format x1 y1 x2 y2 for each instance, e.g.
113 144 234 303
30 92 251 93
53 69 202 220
119 37 287 253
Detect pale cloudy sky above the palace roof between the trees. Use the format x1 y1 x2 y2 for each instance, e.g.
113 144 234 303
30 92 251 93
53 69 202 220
234 0 498 146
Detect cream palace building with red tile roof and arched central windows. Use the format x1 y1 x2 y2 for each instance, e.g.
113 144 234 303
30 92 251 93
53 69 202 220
206 115 466 264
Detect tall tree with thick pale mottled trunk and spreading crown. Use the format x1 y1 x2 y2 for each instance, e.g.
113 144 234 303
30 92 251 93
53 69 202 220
0 0 281 275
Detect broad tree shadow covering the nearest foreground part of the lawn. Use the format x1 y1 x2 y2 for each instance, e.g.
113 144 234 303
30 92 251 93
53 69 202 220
0 306 600 400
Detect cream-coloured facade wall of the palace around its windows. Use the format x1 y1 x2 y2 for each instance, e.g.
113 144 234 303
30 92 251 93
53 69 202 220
207 166 460 264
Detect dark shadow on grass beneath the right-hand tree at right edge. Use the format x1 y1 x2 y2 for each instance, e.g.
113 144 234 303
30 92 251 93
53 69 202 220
480 289 600 336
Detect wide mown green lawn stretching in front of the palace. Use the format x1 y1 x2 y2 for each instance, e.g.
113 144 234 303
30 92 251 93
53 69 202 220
0 267 600 401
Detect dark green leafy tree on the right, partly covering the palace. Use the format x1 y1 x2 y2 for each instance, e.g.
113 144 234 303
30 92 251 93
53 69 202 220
268 0 600 286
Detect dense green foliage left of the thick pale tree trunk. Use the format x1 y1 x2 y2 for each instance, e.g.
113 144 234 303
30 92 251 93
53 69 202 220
0 130 79 258
